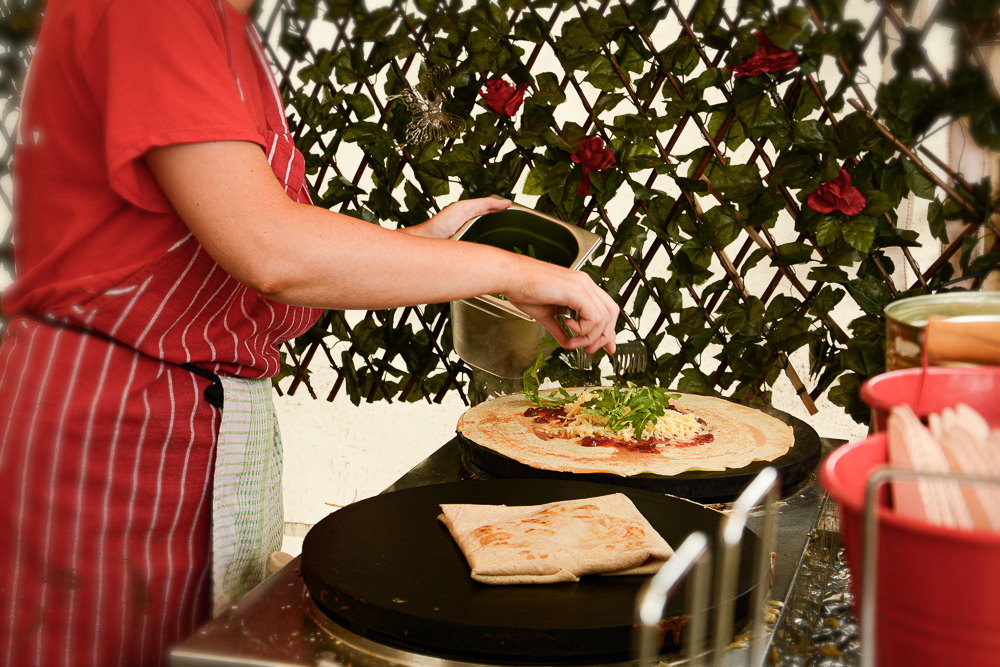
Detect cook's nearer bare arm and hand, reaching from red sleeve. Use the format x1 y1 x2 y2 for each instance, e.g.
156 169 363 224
146 141 618 351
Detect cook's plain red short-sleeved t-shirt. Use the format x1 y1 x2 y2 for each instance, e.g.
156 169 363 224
4 0 265 315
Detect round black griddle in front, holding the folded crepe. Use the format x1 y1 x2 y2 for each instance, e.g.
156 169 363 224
301 479 759 665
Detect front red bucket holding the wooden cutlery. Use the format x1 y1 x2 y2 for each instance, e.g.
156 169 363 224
820 436 1000 667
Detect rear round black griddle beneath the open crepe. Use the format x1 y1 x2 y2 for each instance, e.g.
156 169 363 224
458 405 821 503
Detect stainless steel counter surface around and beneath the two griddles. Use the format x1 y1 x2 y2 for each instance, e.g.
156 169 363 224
170 440 857 667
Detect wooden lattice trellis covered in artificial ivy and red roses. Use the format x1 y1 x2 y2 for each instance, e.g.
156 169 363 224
0 0 1000 421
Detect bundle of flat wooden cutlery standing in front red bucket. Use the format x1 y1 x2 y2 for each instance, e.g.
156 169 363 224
887 404 1000 531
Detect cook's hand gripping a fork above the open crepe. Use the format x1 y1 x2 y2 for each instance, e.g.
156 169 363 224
504 257 619 354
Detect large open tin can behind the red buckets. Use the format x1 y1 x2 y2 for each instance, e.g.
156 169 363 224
884 292 1000 371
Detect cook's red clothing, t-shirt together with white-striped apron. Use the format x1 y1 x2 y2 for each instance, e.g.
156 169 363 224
0 0 317 665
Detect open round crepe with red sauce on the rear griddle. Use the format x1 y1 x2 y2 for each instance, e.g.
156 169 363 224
458 388 794 476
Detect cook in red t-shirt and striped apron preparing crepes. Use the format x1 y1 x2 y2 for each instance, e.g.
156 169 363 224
0 0 618 667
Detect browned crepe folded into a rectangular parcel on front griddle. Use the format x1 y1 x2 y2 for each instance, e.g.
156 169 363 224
438 493 673 584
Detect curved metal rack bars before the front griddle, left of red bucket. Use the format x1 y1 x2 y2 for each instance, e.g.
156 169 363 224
633 466 780 667
